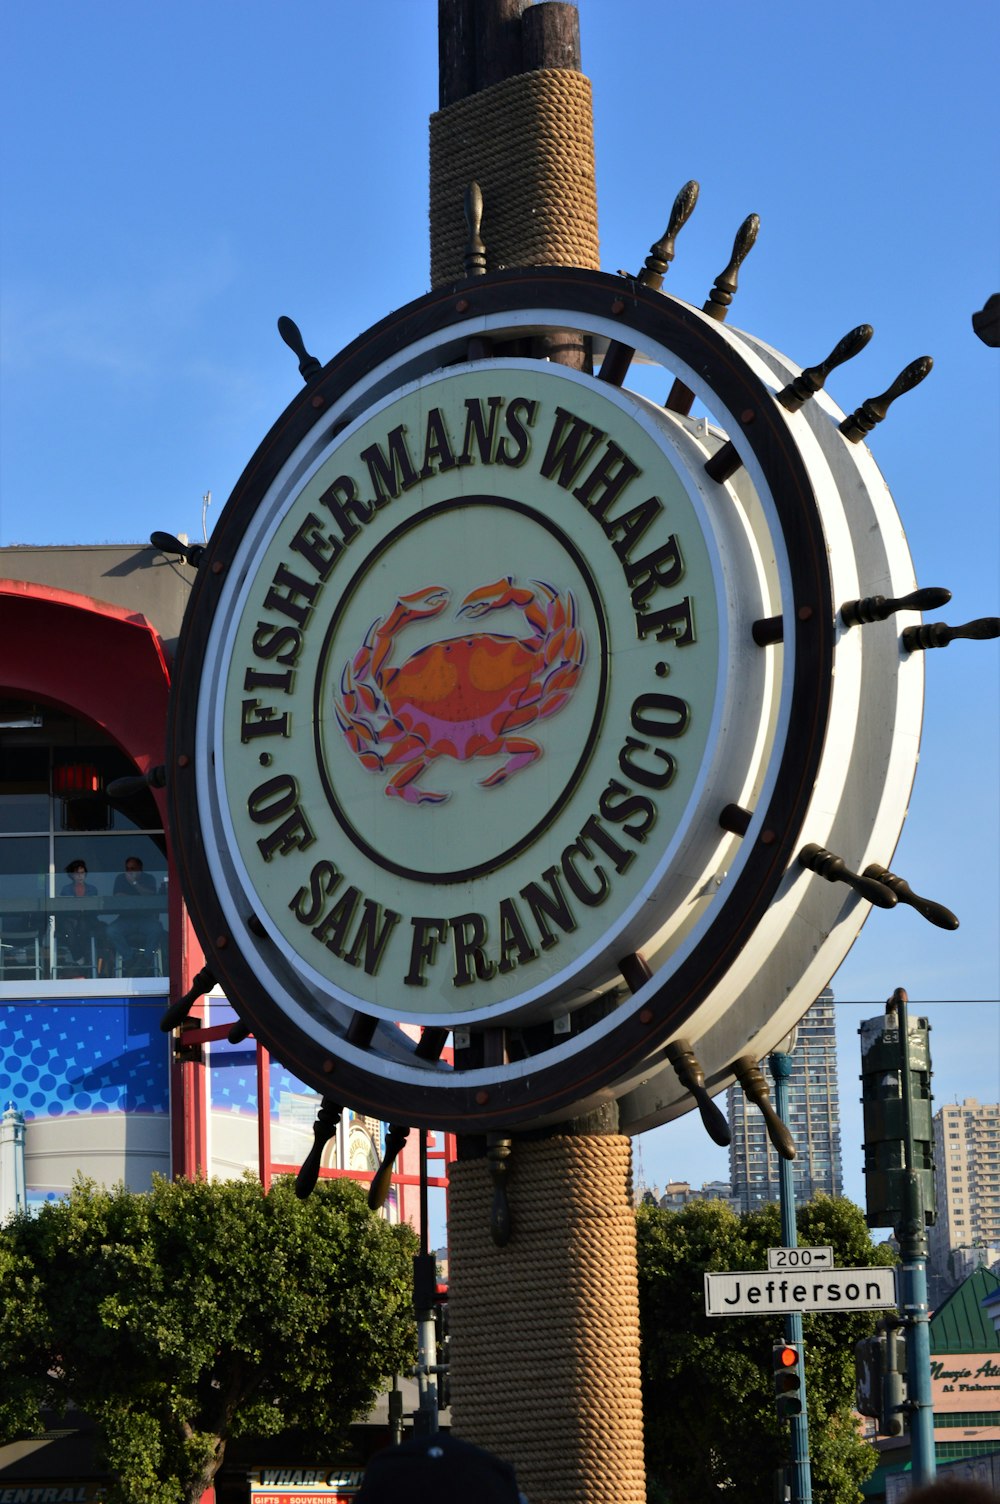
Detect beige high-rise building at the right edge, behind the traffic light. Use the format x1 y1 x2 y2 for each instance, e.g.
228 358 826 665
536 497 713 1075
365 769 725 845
929 1096 1000 1299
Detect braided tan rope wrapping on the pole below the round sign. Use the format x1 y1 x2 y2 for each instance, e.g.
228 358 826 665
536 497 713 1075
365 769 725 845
448 1136 645 1504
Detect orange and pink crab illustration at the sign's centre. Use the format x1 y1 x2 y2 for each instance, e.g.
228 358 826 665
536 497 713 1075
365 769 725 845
334 576 586 805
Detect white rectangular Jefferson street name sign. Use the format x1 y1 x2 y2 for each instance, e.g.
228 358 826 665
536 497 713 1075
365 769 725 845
705 1268 896 1316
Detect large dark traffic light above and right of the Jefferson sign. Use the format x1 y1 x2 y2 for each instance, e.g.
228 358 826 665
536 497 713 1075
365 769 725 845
859 1009 935 1227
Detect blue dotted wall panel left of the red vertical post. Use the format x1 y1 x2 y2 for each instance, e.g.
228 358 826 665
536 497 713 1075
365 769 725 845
0 997 170 1122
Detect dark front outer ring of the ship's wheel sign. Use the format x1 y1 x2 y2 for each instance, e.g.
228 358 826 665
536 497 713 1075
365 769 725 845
167 268 835 1133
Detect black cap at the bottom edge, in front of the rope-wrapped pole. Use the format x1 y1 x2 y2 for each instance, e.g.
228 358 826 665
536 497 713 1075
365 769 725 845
356 1430 520 1504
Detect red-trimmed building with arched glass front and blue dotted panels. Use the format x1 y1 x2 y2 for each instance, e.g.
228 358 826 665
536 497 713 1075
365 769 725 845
0 546 445 1498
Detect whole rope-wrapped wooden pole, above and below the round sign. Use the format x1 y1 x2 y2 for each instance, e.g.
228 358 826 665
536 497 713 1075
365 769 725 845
430 0 645 1504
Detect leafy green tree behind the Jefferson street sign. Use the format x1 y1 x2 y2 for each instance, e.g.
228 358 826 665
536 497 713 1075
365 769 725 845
638 1197 893 1504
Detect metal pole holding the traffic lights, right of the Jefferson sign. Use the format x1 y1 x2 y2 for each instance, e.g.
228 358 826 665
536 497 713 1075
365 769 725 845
886 987 937 1487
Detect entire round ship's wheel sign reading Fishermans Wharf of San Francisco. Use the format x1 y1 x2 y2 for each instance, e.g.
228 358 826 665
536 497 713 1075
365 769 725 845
170 269 938 1128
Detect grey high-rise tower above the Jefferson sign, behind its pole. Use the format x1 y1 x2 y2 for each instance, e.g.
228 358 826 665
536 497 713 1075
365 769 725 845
726 987 844 1211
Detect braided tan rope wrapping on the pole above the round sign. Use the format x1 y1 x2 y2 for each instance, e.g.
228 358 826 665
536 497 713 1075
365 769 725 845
430 68 600 287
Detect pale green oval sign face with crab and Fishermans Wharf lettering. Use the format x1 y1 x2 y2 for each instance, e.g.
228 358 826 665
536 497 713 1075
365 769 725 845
215 361 722 1021
